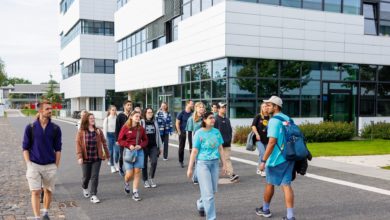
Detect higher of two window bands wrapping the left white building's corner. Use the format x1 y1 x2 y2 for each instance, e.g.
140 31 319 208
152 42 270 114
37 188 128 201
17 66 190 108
61 19 114 48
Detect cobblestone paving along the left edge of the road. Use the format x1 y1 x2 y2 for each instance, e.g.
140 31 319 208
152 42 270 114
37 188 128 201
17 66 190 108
0 118 65 220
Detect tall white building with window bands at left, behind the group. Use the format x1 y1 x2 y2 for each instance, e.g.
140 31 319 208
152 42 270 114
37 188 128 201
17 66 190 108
59 0 117 118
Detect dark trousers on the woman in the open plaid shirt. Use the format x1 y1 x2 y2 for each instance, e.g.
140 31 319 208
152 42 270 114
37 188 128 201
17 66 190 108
81 160 102 196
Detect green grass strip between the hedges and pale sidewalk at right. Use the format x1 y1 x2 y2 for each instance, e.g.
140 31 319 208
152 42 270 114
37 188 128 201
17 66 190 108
307 140 390 157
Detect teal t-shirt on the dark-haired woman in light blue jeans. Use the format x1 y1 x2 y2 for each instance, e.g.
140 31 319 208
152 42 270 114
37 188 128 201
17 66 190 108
193 128 223 160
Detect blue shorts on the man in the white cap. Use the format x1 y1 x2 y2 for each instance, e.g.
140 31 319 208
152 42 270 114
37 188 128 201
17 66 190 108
265 161 295 186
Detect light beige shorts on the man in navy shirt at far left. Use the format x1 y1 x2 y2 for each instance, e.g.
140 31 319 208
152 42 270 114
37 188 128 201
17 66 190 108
26 162 57 192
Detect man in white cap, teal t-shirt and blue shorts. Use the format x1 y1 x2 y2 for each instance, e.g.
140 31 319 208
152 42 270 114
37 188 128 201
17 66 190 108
256 96 295 220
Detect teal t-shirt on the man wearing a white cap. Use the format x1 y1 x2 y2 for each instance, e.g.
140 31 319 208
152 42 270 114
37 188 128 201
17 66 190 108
266 112 290 167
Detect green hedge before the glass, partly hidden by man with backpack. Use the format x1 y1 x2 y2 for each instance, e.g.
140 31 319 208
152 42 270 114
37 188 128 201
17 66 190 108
233 122 355 144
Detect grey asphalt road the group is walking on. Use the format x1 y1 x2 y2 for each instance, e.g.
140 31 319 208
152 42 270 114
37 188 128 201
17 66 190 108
9 111 390 220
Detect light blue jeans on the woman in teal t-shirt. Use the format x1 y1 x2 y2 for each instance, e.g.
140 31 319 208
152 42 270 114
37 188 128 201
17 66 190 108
196 159 219 220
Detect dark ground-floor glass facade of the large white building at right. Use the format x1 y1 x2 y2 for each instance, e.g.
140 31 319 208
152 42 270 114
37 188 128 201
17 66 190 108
125 58 390 122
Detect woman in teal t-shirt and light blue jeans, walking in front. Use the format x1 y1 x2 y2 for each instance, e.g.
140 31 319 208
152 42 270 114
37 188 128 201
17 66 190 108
187 112 226 220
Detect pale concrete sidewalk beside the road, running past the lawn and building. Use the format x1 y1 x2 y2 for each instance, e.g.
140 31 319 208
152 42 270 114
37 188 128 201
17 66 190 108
58 118 390 180
